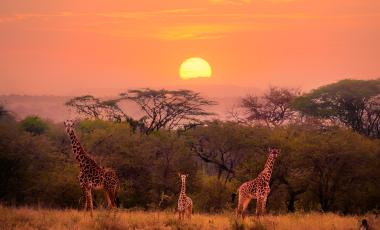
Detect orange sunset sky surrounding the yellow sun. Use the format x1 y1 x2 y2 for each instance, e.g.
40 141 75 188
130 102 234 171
0 0 380 95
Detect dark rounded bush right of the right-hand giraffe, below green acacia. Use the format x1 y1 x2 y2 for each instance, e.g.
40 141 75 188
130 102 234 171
295 126 378 211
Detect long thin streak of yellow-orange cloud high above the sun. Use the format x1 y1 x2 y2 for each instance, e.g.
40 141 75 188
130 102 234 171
0 6 380 40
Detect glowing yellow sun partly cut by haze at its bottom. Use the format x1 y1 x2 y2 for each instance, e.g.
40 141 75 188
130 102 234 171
179 58 211 79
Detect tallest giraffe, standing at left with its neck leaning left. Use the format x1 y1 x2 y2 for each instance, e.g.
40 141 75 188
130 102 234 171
63 120 120 219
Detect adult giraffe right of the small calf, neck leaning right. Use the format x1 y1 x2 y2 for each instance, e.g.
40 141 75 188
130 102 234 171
232 147 281 221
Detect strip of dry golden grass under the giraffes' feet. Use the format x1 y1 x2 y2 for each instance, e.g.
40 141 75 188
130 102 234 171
0 205 380 230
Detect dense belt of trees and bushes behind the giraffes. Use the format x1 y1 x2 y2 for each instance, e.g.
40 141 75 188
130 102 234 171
0 80 380 214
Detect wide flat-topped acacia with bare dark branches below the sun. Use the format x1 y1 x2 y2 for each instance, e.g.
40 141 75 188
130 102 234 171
120 88 218 134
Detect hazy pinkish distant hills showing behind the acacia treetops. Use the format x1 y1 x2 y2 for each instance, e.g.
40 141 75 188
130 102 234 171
0 85 249 121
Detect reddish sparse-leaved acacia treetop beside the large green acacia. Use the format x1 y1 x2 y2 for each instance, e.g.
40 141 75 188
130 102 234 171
229 86 300 126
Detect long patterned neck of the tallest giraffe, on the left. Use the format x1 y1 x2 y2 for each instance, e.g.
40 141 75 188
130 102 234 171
69 130 100 171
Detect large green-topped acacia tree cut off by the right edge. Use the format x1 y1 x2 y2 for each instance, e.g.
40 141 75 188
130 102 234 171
293 78 380 137
